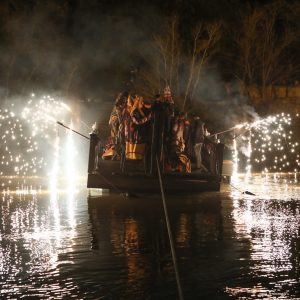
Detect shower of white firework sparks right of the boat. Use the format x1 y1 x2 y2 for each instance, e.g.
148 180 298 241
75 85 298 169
235 113 300 173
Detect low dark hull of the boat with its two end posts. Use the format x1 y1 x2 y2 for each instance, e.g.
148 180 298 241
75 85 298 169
87 127 224 193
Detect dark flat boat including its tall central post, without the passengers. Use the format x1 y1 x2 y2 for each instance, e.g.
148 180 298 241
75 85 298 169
87 97 224 193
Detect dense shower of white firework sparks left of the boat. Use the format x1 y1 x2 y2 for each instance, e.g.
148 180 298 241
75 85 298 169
0 95 71 176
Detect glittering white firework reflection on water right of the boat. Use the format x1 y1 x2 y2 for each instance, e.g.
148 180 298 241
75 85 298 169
227 175 300 299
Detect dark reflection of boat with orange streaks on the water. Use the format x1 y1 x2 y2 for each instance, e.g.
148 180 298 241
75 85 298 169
88 194 222 299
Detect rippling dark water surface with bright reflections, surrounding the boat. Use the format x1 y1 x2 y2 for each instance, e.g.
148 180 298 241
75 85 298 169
0 175 300 299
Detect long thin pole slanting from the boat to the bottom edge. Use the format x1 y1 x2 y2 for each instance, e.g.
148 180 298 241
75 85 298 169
156 155 183 300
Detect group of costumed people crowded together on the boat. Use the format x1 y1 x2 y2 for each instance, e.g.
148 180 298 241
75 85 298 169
100 86 216 174
